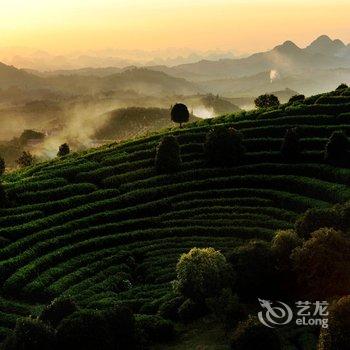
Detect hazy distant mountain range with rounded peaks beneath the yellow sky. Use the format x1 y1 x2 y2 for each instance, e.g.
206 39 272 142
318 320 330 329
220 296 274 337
0 35 350 97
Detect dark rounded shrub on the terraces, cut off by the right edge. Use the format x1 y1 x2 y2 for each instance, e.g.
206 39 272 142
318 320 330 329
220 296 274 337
324 131 349 166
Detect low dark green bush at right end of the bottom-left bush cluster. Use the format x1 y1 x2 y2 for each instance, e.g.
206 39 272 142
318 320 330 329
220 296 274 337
136 315 175 342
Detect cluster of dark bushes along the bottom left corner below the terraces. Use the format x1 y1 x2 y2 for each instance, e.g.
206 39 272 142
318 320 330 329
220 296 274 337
1 298 174 350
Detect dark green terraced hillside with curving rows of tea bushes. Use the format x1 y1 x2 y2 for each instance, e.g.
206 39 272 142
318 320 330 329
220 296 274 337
0 90 350 337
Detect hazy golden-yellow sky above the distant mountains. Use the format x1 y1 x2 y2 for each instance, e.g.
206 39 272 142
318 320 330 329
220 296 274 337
0 0 350 53
